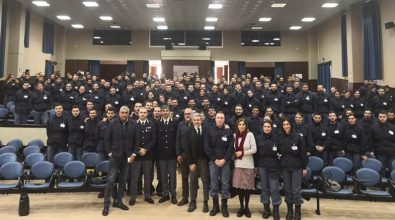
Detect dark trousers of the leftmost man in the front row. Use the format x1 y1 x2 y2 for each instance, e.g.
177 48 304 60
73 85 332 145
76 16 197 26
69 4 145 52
104 157 129 207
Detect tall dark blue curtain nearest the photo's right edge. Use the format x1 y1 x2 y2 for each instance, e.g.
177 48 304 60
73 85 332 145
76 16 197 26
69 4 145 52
363 0 383 80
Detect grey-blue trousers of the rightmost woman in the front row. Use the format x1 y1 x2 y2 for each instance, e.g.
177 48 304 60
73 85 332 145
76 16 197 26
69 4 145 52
283 168 303 205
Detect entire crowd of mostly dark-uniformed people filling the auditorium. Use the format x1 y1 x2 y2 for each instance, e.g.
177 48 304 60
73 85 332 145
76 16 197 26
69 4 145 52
5 69 395 219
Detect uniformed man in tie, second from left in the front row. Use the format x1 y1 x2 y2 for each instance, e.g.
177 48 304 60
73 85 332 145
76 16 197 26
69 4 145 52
129 107 157 206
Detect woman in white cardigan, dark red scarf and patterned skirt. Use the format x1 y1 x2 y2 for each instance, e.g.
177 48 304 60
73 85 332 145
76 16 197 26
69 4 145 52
232 118 256 218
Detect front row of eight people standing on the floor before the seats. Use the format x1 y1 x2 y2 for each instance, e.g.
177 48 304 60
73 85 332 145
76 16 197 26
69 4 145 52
102 106 307 220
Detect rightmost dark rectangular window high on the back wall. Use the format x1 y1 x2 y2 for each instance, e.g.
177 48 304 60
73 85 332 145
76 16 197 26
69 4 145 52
241 31 281 47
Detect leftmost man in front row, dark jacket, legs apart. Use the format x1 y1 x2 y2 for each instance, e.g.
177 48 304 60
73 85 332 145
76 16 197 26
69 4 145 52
102 106 139 216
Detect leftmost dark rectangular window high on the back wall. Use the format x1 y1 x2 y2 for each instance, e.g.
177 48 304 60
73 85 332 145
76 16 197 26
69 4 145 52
92 30 132 45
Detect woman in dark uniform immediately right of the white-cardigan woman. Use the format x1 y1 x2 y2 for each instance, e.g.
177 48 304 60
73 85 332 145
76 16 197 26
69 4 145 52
255 120 281 220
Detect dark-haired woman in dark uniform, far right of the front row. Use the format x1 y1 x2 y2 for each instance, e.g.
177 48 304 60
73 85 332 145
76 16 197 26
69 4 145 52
278 119 307 220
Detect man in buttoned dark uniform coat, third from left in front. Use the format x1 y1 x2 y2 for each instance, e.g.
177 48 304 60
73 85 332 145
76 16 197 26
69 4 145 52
156 105 179 204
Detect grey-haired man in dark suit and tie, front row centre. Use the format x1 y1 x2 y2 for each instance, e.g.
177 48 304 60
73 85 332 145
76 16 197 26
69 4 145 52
183 113 210 213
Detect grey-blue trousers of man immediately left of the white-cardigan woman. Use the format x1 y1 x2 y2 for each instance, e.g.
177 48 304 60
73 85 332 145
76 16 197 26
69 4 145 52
209 161 230 199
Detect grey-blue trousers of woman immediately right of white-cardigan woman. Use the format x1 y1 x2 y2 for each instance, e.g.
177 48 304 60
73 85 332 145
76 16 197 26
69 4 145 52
258 167 281 205
